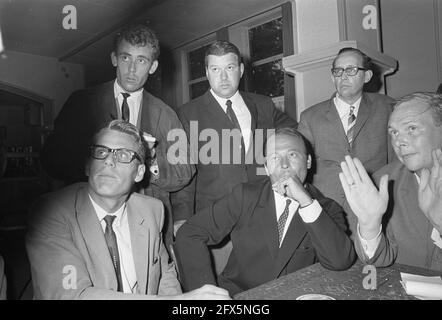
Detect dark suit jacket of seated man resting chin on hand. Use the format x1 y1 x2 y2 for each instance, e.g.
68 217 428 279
175 178 356 295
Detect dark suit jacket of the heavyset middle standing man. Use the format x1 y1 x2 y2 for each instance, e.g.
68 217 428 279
174 91 296 220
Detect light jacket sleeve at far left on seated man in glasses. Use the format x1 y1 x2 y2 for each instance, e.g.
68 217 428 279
26 201 176 300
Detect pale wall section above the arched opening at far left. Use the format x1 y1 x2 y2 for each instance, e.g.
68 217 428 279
0 51 84 117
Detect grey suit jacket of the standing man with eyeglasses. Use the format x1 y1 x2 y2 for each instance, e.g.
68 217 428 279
298 93 395 233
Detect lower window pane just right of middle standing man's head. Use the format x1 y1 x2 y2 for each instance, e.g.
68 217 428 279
252 59 284 97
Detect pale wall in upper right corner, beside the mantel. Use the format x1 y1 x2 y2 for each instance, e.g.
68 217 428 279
380 0 442 98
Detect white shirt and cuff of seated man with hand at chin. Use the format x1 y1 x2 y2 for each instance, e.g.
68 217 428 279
273 190 322 247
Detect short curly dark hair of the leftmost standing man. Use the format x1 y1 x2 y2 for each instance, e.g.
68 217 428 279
114 23 160 61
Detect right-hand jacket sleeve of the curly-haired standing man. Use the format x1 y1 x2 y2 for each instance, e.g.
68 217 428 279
151 106 195 192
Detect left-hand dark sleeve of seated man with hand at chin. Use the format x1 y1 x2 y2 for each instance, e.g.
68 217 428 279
175 185 243 291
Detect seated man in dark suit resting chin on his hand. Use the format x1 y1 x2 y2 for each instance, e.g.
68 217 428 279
175 128 356 295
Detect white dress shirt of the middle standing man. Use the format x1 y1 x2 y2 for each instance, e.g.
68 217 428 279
210 89 252 153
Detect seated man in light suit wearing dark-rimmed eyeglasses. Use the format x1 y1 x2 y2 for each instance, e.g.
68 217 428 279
26 120 229 299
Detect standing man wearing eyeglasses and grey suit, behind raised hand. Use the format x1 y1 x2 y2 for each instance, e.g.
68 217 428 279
298 48 394 235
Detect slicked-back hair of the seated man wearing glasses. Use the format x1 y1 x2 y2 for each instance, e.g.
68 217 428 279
93 119 151 164
